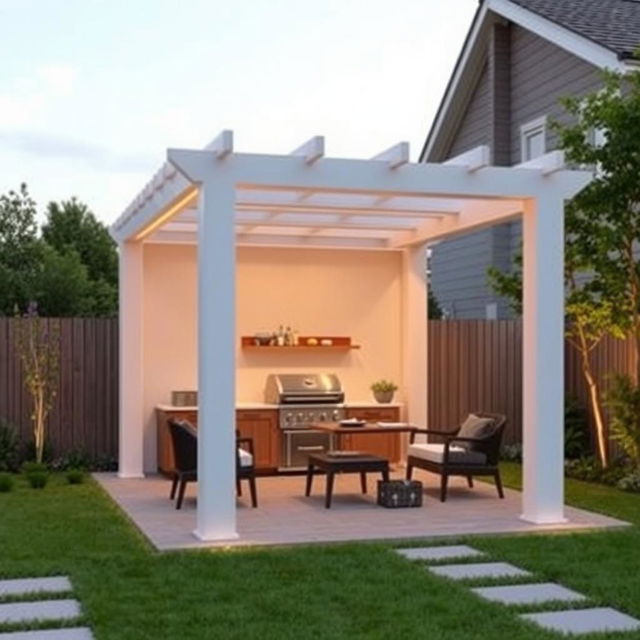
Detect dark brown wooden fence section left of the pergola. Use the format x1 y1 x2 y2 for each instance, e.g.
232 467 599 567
0 318 118 458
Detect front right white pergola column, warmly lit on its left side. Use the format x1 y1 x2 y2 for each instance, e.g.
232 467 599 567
522 193 564 524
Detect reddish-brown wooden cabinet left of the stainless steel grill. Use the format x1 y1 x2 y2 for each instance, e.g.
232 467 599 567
156 407 280 474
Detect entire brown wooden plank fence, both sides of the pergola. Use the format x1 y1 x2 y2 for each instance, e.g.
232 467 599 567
0 318 633 457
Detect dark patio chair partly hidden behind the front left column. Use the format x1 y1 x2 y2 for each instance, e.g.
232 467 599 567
169 419 258 509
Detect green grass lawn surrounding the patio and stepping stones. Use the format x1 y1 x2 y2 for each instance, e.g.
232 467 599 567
0 465 640 640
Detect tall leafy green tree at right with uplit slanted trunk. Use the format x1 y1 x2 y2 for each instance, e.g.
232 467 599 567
489 72 640 466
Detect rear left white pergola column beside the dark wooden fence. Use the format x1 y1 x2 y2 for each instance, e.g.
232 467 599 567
117 242 144 478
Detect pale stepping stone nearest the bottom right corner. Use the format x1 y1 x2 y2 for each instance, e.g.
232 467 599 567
521 607 640 633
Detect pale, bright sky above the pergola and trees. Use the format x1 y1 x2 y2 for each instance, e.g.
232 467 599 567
0 0 478 224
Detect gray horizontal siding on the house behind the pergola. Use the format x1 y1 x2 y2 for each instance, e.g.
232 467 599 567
431 18 600 318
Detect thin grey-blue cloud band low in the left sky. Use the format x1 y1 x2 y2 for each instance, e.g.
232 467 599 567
0 131 157 173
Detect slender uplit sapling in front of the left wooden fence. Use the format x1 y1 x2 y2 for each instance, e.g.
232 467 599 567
16 303 60 463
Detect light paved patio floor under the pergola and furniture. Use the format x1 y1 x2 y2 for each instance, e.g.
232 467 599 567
94 472 626 550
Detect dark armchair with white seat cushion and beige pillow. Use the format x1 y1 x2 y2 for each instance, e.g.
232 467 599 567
407 413 507 502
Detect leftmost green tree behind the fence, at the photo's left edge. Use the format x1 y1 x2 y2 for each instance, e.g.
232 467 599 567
0 184 42 315
